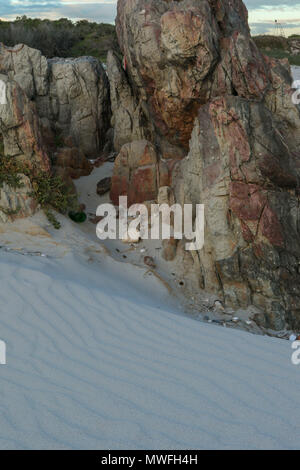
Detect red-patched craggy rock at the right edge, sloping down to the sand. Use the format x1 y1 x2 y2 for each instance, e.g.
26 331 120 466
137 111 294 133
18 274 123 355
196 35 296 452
175 97 300 330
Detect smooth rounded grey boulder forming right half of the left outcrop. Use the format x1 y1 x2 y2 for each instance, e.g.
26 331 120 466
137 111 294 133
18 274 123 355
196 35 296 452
36 57 110 157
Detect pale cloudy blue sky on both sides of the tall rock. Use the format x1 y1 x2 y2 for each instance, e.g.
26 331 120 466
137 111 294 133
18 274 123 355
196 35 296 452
0 0 300 36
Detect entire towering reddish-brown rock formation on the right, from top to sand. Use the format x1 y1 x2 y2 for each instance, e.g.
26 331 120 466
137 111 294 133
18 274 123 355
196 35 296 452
108 0 300 330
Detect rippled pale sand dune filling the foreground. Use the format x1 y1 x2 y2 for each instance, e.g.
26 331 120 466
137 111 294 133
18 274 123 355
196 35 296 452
0 246 300 449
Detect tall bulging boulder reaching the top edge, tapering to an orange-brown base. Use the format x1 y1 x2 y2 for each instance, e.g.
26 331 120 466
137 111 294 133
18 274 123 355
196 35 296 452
113 0 270 154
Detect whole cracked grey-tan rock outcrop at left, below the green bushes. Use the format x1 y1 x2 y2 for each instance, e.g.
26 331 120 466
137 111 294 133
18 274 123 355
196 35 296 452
0 45 110 216
